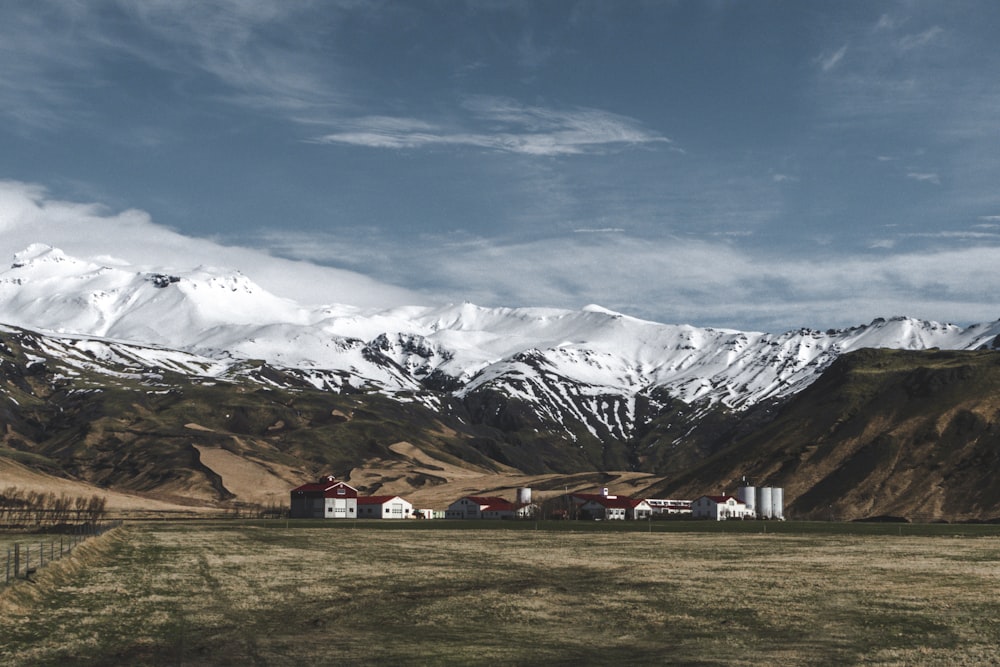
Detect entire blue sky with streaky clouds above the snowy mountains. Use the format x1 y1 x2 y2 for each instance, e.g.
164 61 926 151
0 0 1000 332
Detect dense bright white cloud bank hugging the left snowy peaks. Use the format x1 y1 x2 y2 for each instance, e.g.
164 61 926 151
0 181 423 310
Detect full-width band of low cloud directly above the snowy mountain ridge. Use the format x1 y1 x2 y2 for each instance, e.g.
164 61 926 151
7 181 1000 331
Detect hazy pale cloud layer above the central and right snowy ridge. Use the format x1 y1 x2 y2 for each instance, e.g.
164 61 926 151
254 222 1000 331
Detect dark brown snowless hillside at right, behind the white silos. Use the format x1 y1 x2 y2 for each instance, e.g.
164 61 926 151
652 350 1000 520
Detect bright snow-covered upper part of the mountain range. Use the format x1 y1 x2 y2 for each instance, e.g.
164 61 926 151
0 245 1000 439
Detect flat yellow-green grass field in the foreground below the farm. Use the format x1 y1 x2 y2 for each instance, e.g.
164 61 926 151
0 522 1000 666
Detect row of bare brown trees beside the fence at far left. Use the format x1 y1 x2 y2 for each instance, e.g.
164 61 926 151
0 486 107 528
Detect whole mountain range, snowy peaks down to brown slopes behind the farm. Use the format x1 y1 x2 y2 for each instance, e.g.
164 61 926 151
0 246 1000 520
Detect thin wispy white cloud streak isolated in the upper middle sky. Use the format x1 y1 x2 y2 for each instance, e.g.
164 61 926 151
314 97 671 156
